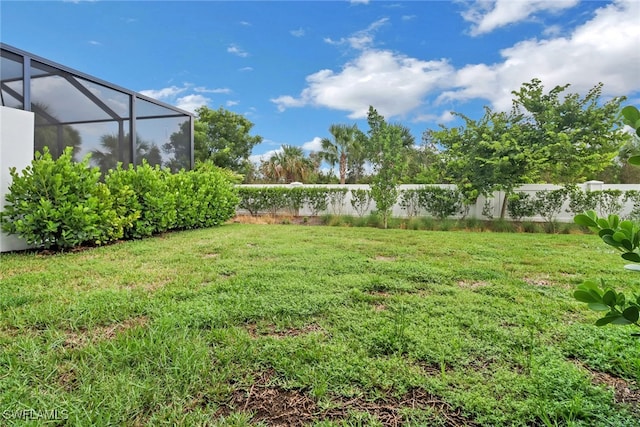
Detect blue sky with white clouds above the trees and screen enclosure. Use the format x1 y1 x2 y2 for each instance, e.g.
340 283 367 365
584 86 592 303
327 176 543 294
0 0 640 164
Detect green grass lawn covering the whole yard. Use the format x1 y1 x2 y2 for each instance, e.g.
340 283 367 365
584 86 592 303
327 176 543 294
0 224 640 426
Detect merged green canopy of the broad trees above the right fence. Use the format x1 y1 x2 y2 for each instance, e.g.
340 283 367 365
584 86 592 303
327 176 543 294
423 79 630 215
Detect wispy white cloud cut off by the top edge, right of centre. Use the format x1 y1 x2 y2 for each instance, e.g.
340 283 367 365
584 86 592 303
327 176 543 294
462 0 579 35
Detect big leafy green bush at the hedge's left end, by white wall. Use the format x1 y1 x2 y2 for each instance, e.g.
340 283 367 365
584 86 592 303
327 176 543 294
0 147 124 249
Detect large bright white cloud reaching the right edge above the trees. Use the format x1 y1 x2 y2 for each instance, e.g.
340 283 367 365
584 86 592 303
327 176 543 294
439 0 640 110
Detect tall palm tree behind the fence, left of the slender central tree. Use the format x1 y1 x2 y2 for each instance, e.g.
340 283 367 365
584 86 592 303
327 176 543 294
320 124 364 184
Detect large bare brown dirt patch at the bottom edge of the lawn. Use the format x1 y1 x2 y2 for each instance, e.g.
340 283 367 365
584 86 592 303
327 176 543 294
216 372 477 427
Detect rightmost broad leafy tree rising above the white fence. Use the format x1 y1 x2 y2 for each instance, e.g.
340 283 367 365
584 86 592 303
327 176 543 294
512 79 629 184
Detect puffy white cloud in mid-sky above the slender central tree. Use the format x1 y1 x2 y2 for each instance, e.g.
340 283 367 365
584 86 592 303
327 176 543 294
271 50 454 119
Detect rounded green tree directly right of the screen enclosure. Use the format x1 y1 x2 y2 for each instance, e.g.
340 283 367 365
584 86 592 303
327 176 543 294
194 106 262 173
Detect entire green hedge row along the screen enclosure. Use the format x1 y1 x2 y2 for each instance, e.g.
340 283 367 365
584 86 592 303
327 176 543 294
0 147 238 249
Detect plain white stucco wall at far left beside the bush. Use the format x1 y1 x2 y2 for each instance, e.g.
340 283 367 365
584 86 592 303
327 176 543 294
0 106 34 252
